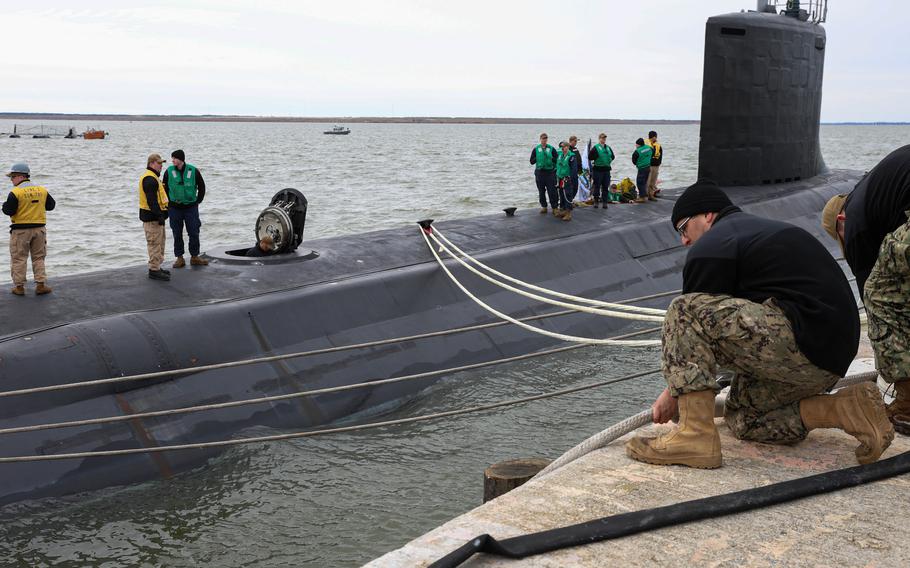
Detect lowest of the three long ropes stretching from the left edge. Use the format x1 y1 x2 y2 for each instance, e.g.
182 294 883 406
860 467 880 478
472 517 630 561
0 369 660 463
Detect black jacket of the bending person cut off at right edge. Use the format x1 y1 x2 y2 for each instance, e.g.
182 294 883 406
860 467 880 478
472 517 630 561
844 145 910 296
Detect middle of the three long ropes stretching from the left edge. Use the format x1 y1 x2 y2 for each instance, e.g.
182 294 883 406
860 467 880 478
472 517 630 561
0 327 660 435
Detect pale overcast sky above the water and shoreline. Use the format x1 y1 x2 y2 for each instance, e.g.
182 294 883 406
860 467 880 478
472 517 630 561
0 0 910 121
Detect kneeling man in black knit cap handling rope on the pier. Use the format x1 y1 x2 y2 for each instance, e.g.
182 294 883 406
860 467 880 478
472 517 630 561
626 180 894 468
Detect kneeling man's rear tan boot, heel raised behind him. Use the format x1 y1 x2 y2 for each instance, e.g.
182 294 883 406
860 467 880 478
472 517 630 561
799 383 894 463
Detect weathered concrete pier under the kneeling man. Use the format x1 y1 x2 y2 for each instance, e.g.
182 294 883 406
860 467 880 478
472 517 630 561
368 366 910 567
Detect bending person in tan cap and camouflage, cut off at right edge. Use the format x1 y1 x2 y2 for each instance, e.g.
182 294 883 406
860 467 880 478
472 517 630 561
822 146 910 435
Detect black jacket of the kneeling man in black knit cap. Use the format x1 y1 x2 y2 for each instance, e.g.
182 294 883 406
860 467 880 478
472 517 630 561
683 207 860 375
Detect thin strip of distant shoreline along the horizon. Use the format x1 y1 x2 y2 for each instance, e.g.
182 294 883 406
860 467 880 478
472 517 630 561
0 112 910 126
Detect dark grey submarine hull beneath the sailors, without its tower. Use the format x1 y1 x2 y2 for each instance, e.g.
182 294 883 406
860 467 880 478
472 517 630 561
0 171 859 503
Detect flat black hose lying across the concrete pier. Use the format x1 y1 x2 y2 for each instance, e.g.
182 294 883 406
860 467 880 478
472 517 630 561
430 452 910 568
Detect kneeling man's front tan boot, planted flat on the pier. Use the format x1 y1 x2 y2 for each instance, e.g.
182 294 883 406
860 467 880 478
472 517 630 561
626 390 723 469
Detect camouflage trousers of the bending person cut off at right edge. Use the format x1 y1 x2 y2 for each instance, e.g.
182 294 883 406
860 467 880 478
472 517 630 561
863 211 910 383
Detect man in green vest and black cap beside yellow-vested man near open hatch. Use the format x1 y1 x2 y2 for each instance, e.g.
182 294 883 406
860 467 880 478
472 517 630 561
163 150 209 268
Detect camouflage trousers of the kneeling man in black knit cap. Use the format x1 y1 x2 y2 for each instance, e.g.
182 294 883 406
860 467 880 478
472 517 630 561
662 294 840 444
